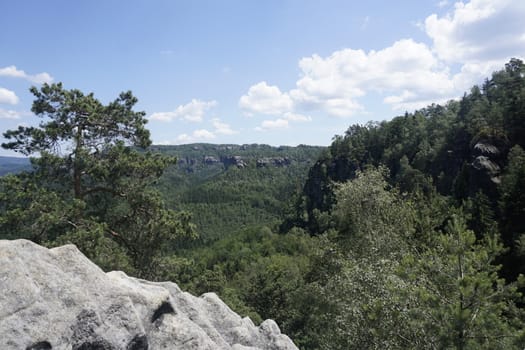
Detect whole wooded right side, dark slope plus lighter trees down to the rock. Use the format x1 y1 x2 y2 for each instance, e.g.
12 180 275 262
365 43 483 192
168 60 525 349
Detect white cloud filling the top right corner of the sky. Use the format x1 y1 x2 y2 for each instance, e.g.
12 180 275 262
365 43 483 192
425 0 525 65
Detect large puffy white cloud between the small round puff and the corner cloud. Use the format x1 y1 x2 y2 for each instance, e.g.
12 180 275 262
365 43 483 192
290 39 456 117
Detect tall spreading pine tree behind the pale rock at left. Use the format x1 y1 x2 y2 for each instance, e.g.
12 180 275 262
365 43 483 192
0 84 193 278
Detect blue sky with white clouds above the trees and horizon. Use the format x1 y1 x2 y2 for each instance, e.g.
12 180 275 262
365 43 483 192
0 0 525 155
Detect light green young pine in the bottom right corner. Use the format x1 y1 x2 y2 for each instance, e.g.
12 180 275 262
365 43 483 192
399 215 523 349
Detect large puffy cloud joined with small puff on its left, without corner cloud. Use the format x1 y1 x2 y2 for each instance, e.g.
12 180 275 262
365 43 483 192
239 39 461 116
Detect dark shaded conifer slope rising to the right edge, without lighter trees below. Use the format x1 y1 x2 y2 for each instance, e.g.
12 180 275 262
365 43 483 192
286 60 525 279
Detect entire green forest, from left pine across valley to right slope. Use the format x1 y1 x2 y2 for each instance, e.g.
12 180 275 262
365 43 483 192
0 59 525 349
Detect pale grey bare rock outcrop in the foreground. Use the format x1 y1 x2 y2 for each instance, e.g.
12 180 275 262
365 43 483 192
0 240 297 350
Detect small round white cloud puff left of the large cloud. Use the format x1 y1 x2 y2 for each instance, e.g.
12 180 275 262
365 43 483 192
239 81 293 115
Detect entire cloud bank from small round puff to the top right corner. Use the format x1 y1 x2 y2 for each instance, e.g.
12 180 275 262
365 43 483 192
243 0 525 117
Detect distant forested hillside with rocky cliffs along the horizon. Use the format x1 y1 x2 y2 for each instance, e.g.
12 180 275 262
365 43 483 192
152 143 324 242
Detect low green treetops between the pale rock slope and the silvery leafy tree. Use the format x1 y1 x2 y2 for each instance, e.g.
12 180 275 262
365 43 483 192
164 227 319 346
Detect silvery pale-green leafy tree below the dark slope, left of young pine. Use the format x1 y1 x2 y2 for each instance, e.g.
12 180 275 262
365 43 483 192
312 168 417 349
